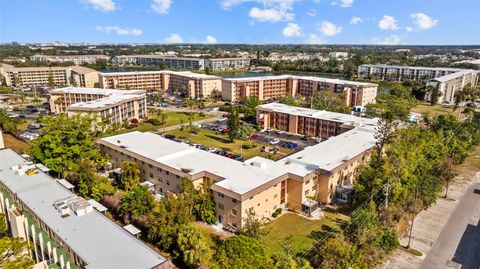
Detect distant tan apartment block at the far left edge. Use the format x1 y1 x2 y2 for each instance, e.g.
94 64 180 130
0 64 71 87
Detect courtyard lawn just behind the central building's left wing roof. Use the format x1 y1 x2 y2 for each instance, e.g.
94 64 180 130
165 129 292 159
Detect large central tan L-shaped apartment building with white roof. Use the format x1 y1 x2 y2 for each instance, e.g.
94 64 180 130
97 103 376 227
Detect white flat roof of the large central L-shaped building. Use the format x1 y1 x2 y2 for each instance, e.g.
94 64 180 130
101 104 376 195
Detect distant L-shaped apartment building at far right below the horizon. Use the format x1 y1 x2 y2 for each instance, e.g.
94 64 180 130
358 64 479 103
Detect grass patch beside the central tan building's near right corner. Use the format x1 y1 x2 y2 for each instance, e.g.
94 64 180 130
262 211 347 253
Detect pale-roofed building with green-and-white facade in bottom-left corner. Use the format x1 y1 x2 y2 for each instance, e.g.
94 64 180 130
0 149 173 269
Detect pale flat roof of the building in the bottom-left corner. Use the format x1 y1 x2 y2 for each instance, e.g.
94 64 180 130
0 149 166 269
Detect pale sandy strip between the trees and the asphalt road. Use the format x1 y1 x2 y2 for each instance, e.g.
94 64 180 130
378 172 480 269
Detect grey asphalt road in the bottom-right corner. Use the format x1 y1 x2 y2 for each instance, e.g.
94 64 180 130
420 183 480 269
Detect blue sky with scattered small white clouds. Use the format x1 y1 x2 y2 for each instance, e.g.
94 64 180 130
0 0 480 45
